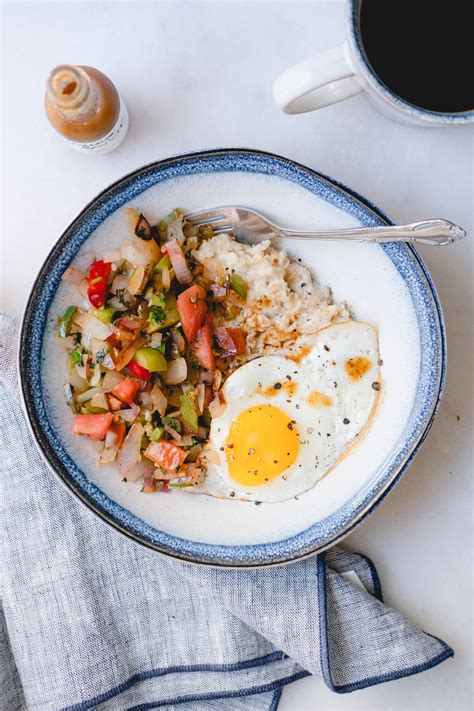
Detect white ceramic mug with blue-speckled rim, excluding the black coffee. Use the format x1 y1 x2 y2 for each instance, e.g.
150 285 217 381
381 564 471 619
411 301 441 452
273 0 474 126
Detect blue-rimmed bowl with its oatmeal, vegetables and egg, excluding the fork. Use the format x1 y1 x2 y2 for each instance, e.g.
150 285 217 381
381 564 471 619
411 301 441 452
20 149 445 567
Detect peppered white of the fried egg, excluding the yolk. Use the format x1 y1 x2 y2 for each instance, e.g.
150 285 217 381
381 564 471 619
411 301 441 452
189 321 381 503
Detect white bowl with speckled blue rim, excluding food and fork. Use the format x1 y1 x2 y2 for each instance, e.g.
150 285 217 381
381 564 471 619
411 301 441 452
19 149 446 567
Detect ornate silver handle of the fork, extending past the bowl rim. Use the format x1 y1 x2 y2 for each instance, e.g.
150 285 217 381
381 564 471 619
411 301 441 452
277 219 466 246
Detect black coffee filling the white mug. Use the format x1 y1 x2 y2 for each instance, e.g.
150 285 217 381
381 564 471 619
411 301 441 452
360 0 474 113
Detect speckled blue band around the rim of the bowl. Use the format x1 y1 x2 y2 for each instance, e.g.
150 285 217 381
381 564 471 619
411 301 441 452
19 148 446 567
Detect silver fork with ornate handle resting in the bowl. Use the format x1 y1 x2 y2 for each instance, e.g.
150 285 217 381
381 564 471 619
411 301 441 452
186 206 466 246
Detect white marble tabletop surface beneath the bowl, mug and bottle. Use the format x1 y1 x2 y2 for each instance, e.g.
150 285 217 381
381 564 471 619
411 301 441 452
1 0 473 711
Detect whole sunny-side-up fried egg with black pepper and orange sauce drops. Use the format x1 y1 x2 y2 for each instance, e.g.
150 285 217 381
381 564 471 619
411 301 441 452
193 321 381 502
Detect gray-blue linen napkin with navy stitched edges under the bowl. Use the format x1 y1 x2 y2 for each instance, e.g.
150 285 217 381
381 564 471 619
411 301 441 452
0 314 453 711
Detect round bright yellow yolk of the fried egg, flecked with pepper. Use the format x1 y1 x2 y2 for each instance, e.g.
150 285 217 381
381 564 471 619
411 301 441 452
225 405 299 486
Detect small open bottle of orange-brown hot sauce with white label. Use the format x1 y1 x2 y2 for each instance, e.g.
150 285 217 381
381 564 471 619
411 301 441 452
45 64 128 155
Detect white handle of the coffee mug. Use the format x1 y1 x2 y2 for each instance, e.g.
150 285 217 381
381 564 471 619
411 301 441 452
273 44 364 114
